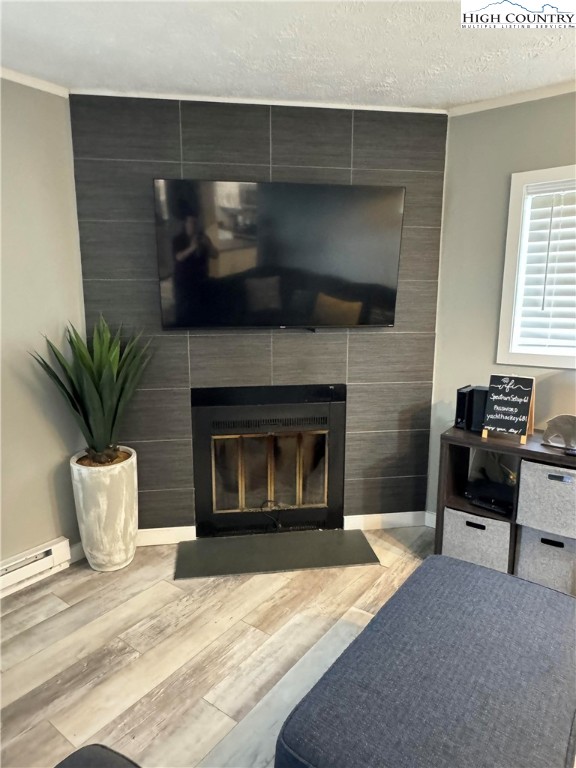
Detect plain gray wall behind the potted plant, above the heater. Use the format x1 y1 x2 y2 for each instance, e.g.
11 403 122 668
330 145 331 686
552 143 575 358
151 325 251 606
1 80 84 558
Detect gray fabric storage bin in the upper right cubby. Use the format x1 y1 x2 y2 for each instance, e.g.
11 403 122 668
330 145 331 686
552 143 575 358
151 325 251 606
516 461 576 539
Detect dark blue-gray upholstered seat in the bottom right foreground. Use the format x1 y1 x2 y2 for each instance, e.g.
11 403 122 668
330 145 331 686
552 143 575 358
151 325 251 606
275 556 576 768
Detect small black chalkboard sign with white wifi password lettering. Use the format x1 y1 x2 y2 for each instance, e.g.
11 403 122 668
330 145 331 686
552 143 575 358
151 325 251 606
482 376 534 443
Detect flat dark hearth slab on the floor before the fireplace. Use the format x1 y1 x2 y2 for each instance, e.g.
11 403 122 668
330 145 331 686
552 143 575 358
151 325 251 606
174 530 379 579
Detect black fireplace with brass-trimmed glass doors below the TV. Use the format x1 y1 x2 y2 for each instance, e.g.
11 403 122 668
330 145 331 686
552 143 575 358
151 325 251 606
191 384 346 537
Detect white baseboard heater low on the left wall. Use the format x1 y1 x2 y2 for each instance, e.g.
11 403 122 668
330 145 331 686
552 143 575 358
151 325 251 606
0 536 70 597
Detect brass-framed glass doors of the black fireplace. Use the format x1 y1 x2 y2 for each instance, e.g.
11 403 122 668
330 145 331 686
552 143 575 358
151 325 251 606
212 431 328 514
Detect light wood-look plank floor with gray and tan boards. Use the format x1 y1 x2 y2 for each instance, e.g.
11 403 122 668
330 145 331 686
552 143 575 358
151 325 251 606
1 527 433 768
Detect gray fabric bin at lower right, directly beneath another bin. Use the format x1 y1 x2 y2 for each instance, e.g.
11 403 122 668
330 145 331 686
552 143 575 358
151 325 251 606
514 526 576 595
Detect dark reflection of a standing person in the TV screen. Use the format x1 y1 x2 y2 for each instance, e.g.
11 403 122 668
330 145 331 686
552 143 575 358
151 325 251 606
172 209 218 326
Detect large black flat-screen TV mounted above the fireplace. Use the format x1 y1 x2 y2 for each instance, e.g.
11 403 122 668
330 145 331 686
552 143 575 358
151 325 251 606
154 179 405 328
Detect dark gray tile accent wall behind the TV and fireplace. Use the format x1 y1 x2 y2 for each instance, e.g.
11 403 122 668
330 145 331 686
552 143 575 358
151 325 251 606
70 96 446 528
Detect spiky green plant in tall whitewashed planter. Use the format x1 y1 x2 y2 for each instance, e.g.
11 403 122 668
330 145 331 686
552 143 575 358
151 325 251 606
32 317 150 571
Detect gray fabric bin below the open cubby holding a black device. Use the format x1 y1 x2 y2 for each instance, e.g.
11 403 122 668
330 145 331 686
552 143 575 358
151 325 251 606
442 507 511 573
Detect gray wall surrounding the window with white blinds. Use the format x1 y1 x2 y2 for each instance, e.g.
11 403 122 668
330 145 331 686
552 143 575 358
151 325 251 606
427 94 576 510
